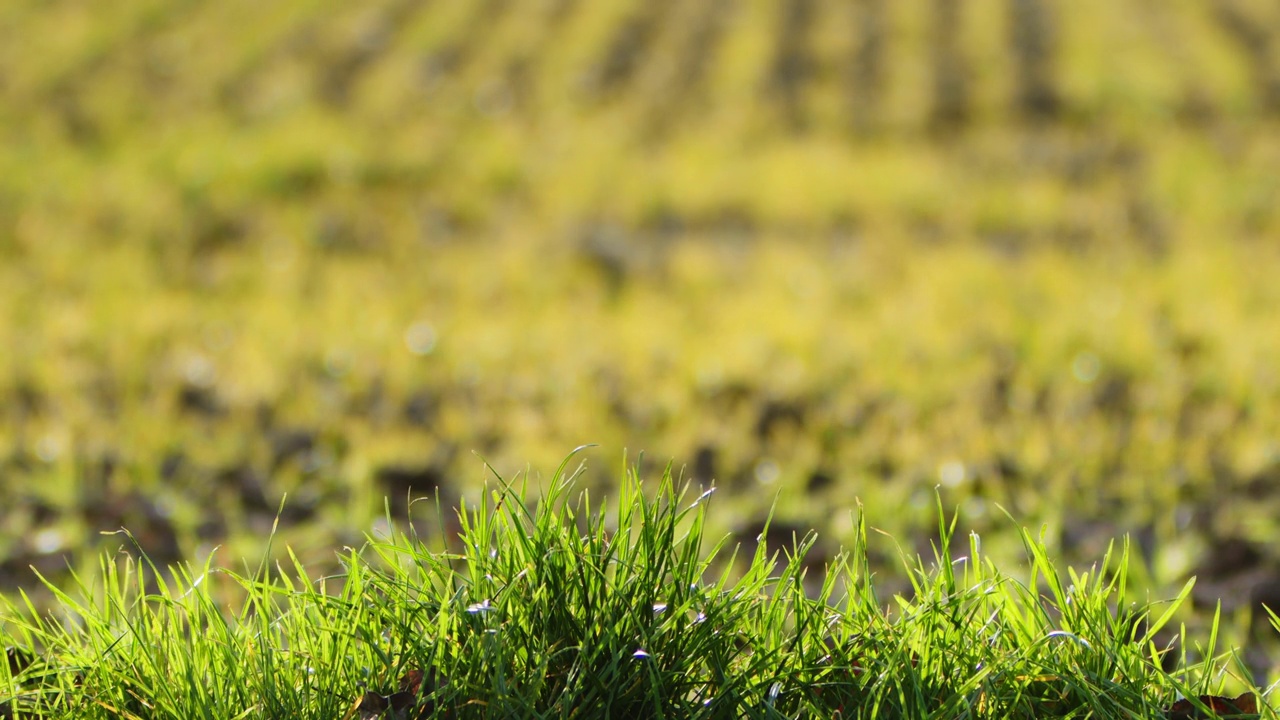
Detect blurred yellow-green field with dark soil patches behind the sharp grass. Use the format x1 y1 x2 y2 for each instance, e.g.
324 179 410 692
0 0 1280 676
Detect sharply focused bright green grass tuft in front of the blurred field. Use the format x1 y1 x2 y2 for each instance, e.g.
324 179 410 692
0 450 1274 720
